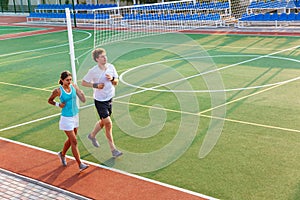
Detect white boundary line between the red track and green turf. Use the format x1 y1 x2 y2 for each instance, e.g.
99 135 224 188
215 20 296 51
0 137 217 200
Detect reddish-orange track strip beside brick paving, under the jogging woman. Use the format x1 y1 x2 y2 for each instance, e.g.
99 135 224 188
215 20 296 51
0 138 213 200
